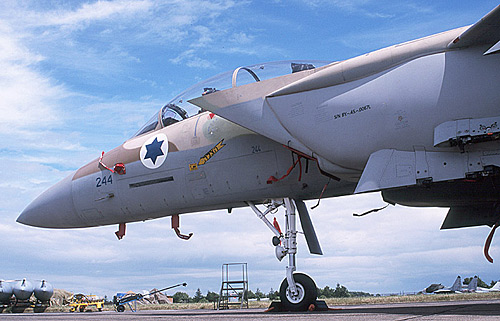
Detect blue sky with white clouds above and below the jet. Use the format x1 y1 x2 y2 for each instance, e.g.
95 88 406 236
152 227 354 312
0 0 500 296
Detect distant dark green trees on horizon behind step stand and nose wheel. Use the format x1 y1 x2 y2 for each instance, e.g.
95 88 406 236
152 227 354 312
172 283 372 303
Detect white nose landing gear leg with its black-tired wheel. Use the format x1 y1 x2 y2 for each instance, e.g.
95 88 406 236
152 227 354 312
247 198 317 311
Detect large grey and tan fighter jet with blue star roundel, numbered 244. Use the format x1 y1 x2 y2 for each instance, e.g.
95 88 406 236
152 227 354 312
17 6 500 310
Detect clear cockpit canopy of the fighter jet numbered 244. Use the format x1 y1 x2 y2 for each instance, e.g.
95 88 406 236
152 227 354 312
134 60 330 137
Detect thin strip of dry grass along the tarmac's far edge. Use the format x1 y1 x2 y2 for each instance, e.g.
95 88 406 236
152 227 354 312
39 292 500 313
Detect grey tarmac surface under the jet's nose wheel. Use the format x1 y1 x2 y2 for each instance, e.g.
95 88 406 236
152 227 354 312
0 300 500 321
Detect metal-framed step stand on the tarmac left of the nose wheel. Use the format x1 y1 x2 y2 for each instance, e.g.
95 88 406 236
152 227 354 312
217 263 248 310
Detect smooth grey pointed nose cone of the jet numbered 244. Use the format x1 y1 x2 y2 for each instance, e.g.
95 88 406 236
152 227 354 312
17 174 80 228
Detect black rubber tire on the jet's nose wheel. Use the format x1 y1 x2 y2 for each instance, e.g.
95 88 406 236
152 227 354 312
280 273 318 311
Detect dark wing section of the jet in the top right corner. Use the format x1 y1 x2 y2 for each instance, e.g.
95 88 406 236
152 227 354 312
448 5 500 54
